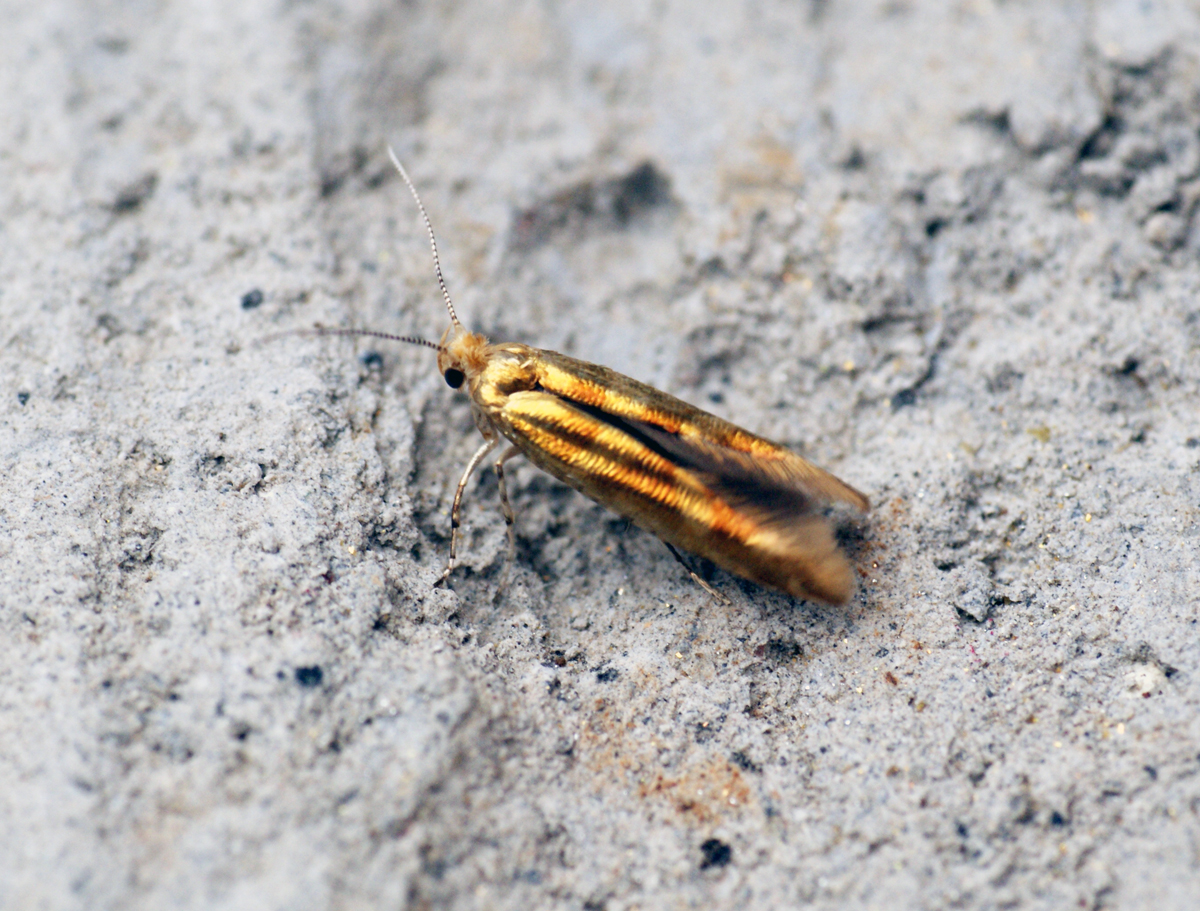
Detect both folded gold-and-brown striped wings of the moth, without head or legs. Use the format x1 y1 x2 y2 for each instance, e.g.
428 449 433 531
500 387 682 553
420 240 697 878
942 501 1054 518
492 352 868 604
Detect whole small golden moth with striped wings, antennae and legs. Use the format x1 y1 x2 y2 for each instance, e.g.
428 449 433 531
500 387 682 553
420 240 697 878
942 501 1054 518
314 148 869 604
